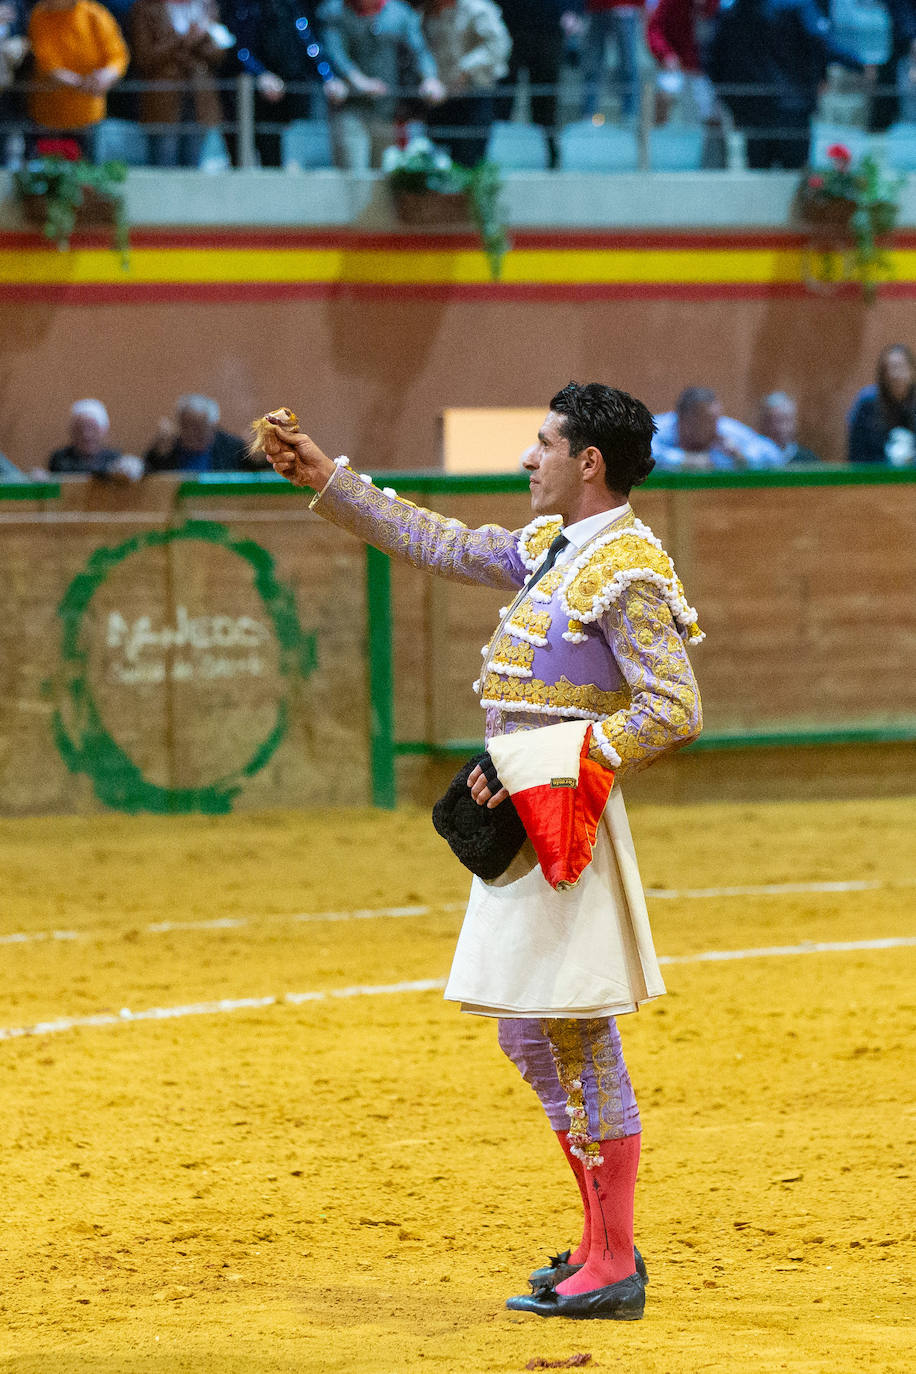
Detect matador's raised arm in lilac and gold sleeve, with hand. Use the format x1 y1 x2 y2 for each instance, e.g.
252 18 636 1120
260 414 527 589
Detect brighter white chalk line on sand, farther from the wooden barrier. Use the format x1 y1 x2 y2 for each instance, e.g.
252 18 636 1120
0 936 916 1040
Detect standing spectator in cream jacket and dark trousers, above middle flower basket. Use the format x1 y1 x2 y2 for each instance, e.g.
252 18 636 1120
420 0 512 166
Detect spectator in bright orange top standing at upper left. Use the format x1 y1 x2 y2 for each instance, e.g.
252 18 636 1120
29 0 129 151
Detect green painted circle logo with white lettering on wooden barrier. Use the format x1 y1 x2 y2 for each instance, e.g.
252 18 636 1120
52 519 317 815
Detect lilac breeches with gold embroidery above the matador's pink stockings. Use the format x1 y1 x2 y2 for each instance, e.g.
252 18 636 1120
500 1017 641 1140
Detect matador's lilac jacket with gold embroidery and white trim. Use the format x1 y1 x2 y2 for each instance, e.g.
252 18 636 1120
312 459 703 778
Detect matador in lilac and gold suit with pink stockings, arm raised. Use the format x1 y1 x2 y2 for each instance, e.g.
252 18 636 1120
255 382 703 1320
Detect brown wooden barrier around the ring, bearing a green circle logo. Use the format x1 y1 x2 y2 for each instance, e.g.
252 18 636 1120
0 477 916 815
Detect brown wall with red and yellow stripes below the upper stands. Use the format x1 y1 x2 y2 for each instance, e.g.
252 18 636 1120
0 229 916 467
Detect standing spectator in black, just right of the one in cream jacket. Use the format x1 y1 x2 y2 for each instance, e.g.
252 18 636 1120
496 0 581 164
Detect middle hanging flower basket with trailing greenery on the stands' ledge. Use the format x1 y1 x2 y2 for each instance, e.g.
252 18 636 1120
382 137 509 282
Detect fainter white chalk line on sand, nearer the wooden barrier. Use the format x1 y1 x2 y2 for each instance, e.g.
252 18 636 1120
0 878 916 945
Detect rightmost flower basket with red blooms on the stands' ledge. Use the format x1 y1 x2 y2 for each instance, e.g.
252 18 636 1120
795 143 906 302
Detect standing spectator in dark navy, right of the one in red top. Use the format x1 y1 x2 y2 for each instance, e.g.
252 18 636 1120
709 0 875 168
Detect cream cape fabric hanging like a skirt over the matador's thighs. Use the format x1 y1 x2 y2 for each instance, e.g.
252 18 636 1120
445 786 665 1018
